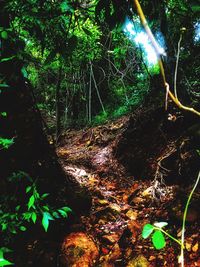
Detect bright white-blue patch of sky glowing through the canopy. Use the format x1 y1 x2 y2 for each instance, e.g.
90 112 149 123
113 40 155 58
123 19 165 66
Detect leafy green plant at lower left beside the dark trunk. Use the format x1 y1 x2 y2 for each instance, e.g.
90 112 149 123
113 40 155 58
0 172 71 236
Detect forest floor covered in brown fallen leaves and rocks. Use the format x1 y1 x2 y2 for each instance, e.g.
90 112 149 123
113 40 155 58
57 110 200 267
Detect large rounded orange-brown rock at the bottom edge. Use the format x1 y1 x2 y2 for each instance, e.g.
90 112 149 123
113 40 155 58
61 232 99 267
